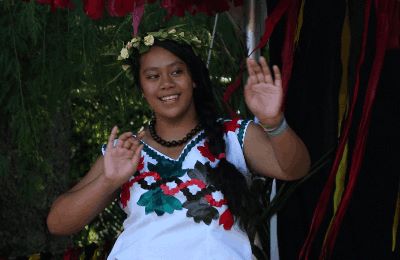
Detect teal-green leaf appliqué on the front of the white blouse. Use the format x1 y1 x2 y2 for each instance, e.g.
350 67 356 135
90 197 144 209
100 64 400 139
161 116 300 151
137 188 182 216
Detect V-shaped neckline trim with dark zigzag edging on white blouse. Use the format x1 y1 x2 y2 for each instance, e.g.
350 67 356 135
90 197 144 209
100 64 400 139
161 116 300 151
142 130 205 163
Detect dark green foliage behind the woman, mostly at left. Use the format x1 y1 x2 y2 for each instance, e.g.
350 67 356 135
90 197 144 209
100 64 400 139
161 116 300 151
0 0 247 256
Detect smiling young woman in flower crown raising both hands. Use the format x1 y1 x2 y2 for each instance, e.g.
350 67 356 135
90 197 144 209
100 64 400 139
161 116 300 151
47 27 310 259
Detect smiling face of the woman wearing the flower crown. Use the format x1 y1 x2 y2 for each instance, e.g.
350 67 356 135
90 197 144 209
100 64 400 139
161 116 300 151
139 46 195 120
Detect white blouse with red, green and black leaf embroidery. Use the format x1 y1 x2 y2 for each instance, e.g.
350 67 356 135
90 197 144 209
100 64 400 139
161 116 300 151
108 119 252 260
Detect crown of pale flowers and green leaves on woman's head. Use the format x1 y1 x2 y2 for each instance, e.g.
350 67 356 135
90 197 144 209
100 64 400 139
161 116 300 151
118 25 209 79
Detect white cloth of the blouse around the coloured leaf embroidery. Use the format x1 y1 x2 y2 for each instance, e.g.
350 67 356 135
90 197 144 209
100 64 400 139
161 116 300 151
108 120 252 260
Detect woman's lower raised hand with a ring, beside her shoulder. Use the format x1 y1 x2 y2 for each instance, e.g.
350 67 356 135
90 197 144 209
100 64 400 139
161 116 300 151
104 126 144 188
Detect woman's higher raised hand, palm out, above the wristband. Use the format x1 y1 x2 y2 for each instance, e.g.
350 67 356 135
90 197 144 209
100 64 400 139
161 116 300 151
244 57 283 126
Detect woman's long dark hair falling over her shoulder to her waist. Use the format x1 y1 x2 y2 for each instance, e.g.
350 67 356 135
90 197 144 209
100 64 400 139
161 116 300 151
133 40 267 259
